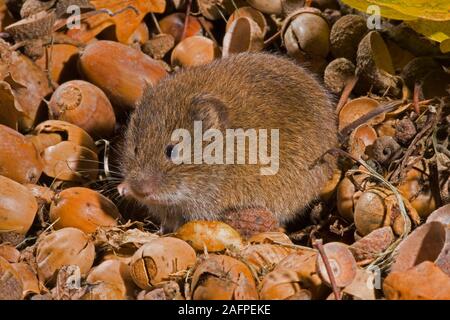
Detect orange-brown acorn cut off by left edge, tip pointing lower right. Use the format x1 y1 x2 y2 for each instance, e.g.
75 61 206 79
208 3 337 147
0 124 43 183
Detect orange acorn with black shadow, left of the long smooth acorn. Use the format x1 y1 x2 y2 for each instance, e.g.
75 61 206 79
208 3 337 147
35 44 80 84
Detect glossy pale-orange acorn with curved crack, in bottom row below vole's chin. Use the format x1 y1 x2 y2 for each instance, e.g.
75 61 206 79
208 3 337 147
130 237 197 289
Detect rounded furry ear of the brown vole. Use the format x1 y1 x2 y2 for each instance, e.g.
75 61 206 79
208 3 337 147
189 94 228 129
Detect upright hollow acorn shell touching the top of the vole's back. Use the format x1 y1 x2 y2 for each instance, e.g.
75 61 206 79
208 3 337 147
222 17 264 57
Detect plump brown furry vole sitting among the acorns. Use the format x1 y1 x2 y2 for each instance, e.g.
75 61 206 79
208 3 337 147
122 53 337 228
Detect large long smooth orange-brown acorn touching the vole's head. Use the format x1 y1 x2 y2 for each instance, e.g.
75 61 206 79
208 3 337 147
79 40 167 111
